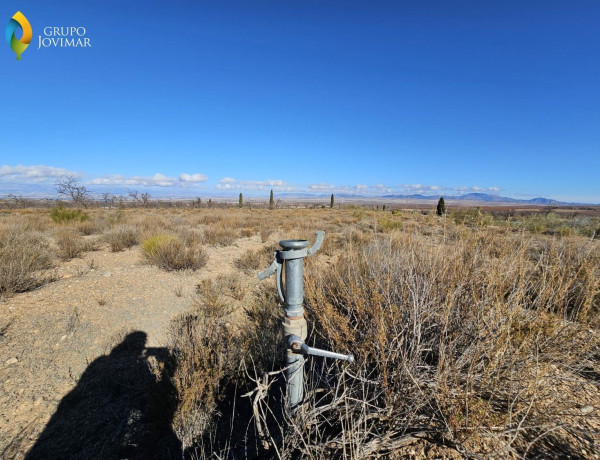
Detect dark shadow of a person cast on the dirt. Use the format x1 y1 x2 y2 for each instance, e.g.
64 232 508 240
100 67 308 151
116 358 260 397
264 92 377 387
26 331 182 460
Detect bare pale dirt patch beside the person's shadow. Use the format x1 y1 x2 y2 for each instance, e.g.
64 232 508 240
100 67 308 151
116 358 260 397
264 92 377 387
0 236 263 459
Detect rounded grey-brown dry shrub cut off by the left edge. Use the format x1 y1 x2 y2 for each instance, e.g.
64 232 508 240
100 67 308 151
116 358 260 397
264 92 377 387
0 226 52 296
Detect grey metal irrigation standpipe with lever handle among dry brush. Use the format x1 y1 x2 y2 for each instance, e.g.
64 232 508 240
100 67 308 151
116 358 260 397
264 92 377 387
258 230 354 413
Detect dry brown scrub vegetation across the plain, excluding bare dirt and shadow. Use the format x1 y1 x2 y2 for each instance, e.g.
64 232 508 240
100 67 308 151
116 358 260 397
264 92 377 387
0 208 600 459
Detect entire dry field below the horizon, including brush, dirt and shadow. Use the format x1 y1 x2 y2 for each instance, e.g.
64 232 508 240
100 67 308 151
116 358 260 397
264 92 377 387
0 207 600 459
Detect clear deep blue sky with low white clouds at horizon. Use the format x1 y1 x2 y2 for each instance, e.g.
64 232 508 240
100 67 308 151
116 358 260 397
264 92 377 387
0 0 600 202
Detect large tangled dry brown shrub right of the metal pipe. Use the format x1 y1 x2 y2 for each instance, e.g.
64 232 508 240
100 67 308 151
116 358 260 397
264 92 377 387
285 233 600 458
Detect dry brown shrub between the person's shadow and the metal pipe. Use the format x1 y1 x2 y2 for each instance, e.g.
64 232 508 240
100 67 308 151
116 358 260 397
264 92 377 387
171 281 283 458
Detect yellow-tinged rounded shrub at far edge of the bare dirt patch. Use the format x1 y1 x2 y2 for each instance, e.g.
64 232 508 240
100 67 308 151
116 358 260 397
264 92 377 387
142 233 208 270
